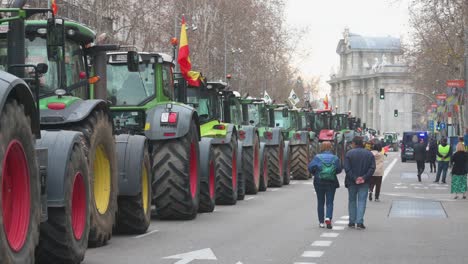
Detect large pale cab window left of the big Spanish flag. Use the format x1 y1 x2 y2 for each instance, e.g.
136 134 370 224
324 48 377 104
107 63 155 106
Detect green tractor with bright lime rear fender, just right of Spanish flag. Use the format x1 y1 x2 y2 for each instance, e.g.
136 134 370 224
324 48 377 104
177 78 239 209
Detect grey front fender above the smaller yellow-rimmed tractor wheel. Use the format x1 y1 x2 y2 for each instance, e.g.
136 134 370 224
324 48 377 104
115 134 149 196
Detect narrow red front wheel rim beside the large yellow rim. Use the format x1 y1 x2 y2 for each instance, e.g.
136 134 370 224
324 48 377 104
71 172 86 240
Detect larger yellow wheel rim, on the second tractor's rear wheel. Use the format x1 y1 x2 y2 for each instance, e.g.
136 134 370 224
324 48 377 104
94 145 111 214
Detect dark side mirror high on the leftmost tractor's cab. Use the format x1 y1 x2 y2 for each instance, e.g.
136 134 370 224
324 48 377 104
47 18 65 61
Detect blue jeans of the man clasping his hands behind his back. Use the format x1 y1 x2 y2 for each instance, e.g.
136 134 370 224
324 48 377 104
348 183 369 224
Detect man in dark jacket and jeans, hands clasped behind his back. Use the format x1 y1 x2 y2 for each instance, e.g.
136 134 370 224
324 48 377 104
344 136 375 229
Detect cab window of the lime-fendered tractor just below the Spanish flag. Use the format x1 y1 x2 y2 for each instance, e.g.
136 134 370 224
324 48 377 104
187 87 220 123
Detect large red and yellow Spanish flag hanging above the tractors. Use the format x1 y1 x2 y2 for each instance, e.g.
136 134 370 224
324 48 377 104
177 17 201 87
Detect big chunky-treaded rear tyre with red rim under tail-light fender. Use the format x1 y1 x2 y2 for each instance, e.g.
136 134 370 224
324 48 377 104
152 121 200 220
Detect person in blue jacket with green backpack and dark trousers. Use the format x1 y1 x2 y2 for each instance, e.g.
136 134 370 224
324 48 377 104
309 141 342 229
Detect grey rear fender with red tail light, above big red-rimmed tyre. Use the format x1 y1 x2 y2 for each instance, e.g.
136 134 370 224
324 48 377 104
145 103 200 140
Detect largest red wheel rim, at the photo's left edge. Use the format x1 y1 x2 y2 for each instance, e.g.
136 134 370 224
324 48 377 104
1 140 31 252
